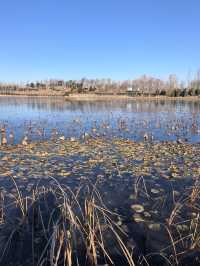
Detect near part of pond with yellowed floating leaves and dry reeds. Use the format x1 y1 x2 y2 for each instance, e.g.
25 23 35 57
0 136 200 265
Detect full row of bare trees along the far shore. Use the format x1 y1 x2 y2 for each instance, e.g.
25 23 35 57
0 71 200 97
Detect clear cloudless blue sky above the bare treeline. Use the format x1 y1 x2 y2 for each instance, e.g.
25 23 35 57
0 0 200 82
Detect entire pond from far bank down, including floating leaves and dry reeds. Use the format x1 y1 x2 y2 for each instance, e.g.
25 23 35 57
0 98 200 266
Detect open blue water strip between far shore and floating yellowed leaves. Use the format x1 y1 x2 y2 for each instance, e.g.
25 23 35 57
0 97 200 143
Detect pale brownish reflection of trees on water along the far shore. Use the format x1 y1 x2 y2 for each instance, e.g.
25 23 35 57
0 97 200 113
